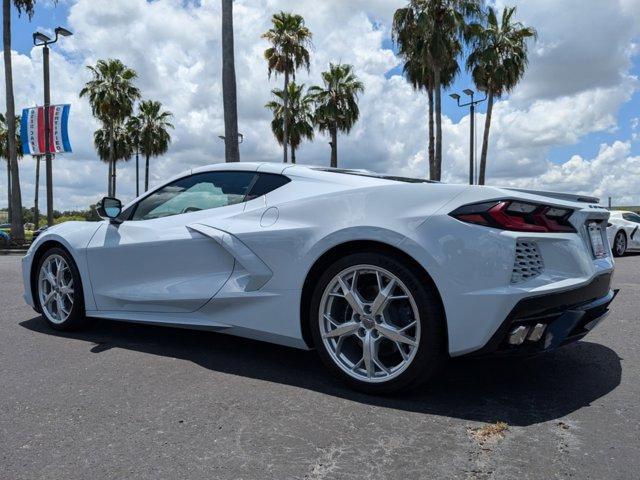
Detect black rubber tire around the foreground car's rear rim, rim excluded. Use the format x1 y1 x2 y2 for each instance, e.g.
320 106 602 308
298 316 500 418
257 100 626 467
309 252 448 394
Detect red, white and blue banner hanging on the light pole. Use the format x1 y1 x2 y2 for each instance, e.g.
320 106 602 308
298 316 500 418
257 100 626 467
20 105 71 155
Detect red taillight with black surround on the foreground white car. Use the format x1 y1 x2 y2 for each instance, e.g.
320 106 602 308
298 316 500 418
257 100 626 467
449 200 576 232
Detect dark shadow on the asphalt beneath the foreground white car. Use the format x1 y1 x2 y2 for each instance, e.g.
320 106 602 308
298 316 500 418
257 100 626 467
20 317 622 426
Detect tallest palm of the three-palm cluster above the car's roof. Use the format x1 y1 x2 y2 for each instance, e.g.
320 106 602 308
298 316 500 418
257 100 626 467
262 12 312 163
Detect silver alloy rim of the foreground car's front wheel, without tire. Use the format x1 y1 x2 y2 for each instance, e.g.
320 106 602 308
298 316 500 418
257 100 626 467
38 255 74 324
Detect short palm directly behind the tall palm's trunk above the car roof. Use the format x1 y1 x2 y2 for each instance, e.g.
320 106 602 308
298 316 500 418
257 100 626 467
265 82 314 163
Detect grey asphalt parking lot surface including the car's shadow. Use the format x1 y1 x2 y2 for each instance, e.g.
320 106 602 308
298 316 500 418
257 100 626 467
0 256 640 480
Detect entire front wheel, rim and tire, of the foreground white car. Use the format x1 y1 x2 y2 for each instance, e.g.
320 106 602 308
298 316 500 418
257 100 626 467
36 248 86 330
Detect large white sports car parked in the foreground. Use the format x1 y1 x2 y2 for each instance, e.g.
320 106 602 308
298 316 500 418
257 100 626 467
23 163 615 393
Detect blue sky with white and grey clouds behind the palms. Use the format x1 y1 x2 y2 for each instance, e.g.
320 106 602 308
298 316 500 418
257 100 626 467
0 0 640 210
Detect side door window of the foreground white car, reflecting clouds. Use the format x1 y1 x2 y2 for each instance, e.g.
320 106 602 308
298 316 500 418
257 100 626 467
131 172 256 220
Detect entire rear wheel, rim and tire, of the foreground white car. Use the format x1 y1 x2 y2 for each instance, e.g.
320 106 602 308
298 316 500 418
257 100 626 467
310 252 446 394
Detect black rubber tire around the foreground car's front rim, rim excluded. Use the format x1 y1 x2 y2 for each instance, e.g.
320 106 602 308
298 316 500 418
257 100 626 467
34 247 88 331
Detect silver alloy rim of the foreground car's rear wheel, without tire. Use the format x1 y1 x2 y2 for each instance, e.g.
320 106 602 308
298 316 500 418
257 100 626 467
319 265 420 383
